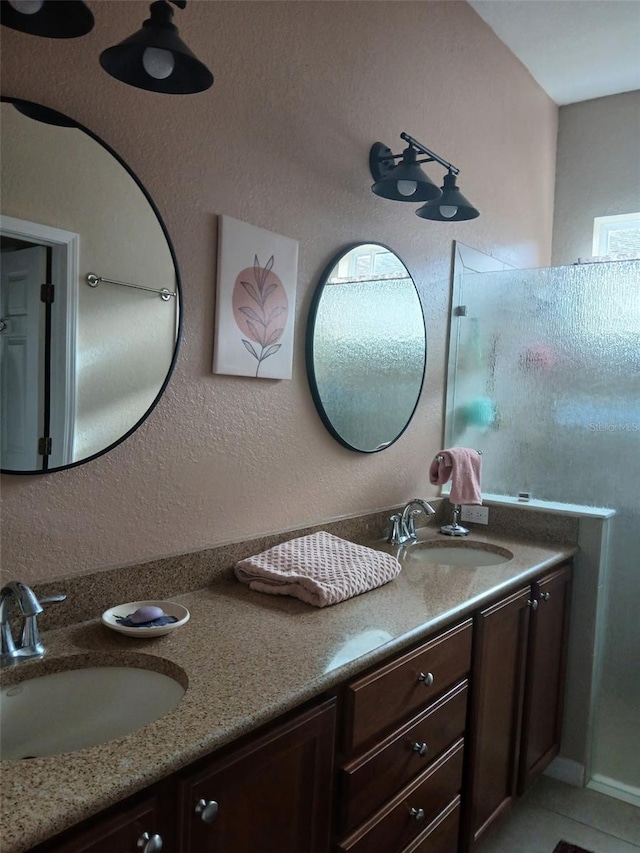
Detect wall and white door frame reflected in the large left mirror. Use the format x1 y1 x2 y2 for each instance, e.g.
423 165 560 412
0 97 181 474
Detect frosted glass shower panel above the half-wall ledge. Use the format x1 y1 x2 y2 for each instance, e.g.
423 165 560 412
446 261 640 506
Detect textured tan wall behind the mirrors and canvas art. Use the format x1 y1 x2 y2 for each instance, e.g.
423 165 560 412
2 0 557 580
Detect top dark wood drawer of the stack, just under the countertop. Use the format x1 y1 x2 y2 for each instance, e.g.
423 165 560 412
344 619 471 753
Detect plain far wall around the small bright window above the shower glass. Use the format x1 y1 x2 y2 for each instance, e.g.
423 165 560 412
552 91 640 266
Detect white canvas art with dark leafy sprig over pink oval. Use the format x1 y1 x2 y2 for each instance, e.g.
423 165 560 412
213 216 298 379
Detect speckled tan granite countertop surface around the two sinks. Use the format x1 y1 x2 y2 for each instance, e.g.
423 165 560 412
1 529 577 853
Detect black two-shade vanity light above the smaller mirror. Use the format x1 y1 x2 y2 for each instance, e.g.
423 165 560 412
369 132 480 222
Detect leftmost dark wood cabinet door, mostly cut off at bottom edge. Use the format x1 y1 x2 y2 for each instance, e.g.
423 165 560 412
35 797 171 853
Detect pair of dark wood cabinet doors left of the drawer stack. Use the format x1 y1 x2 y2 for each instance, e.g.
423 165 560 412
33 698 336 853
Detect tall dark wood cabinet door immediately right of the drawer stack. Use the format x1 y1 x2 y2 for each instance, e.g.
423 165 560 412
462 587 531 850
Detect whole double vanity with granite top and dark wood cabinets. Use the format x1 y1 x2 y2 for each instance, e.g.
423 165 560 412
2 528 576 853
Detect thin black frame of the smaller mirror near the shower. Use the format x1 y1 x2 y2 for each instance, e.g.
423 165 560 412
305 240 427 453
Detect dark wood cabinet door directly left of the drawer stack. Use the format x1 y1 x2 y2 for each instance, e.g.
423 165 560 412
179 699 335 853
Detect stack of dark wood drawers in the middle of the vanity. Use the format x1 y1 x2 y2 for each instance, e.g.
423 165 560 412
336 619 472 853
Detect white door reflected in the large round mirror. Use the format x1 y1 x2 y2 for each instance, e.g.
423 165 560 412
0 246 47 471
